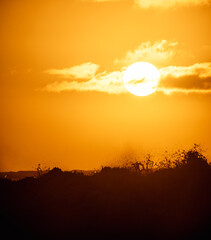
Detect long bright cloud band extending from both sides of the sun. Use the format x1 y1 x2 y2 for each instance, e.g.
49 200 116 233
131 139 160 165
43 62 211 94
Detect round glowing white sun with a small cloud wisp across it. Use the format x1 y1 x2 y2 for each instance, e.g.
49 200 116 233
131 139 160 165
123 62 160 96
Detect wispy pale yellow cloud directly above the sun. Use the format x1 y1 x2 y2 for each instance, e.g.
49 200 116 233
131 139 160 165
114 40 178 66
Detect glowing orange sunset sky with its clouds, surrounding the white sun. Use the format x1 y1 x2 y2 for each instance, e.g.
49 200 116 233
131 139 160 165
0 0 211 171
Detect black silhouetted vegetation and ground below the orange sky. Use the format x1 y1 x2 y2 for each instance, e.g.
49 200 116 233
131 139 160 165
0 145 211 239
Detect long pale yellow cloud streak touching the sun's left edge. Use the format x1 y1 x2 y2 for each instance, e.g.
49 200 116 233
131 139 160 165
44 71 127 94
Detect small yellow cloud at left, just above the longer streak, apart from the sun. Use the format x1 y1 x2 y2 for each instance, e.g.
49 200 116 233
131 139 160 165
46 62 99 79
